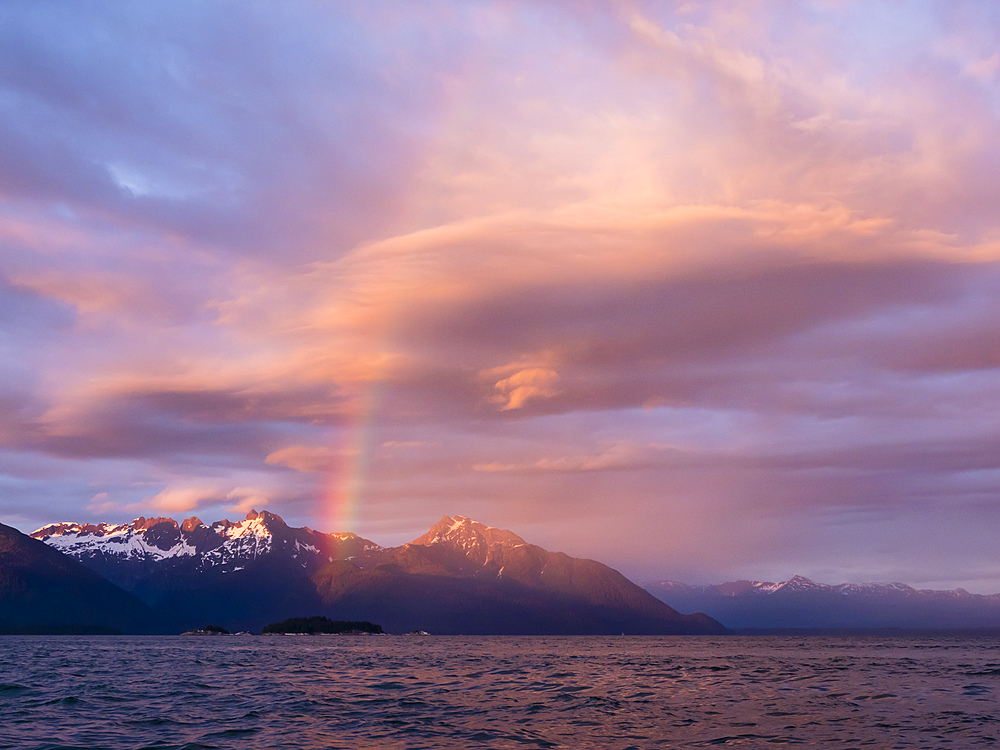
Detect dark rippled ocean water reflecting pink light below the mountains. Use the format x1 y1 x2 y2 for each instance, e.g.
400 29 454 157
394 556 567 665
0 636 1000 750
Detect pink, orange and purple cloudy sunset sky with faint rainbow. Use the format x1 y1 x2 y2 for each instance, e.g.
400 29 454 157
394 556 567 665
0 0 1000 593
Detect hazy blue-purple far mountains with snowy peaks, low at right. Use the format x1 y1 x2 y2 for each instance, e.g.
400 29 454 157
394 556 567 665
644 576 1000 630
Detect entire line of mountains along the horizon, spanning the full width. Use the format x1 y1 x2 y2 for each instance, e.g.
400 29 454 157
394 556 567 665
13 511 1000 634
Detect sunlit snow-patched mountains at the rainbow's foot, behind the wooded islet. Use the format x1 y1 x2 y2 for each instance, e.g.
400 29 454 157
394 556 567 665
23 511 725 634
